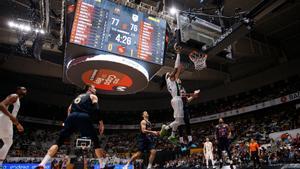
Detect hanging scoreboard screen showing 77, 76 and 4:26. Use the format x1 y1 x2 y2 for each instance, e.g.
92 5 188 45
70 0 166 65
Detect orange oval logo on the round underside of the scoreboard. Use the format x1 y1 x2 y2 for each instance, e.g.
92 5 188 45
81 69 133 92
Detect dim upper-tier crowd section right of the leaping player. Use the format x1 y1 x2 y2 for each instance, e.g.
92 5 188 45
189 76 300 117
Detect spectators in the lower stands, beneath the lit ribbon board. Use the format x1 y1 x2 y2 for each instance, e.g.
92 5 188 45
4 104 300 168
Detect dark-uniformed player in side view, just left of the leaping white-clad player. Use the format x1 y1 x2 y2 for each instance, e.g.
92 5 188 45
123 111 159 169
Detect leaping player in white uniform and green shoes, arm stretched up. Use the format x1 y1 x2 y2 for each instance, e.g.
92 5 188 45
160 44 199 144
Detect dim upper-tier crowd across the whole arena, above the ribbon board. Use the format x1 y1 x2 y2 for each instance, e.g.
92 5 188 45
15 76 300 124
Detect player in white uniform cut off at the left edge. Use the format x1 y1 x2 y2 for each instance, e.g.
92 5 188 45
0 87 27 166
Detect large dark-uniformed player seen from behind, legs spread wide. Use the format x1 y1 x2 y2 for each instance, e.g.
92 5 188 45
37 85 105 169
